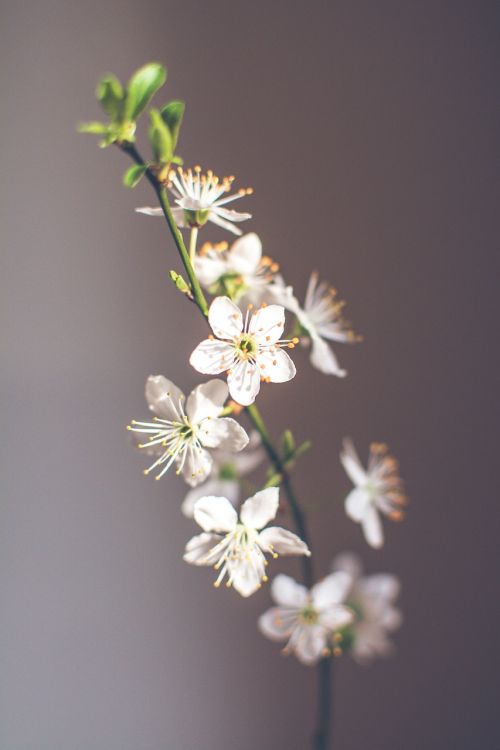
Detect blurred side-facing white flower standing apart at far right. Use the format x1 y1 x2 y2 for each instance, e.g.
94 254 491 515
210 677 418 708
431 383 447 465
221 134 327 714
340 440 408 548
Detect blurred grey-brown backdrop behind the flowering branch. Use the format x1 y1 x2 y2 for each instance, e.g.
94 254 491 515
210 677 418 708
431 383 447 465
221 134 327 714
0 0 500 750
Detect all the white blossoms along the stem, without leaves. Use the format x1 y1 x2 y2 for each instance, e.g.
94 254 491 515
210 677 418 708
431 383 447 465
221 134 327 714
129 167 406 665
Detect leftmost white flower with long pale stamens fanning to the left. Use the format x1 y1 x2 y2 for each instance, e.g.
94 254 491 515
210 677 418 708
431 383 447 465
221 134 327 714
127 375 248 487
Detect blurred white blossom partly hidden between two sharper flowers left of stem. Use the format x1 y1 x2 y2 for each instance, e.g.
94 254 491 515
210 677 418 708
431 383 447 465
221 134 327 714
181 430 265 518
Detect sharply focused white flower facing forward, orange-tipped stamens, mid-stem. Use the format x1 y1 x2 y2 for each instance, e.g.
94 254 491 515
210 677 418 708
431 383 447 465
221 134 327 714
189 297 298 406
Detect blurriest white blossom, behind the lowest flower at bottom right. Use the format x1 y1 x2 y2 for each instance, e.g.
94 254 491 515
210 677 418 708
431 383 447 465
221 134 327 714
332 553 403 664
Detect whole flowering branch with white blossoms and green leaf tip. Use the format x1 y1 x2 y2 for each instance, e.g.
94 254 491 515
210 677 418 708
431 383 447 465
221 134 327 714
80 63 407 750
